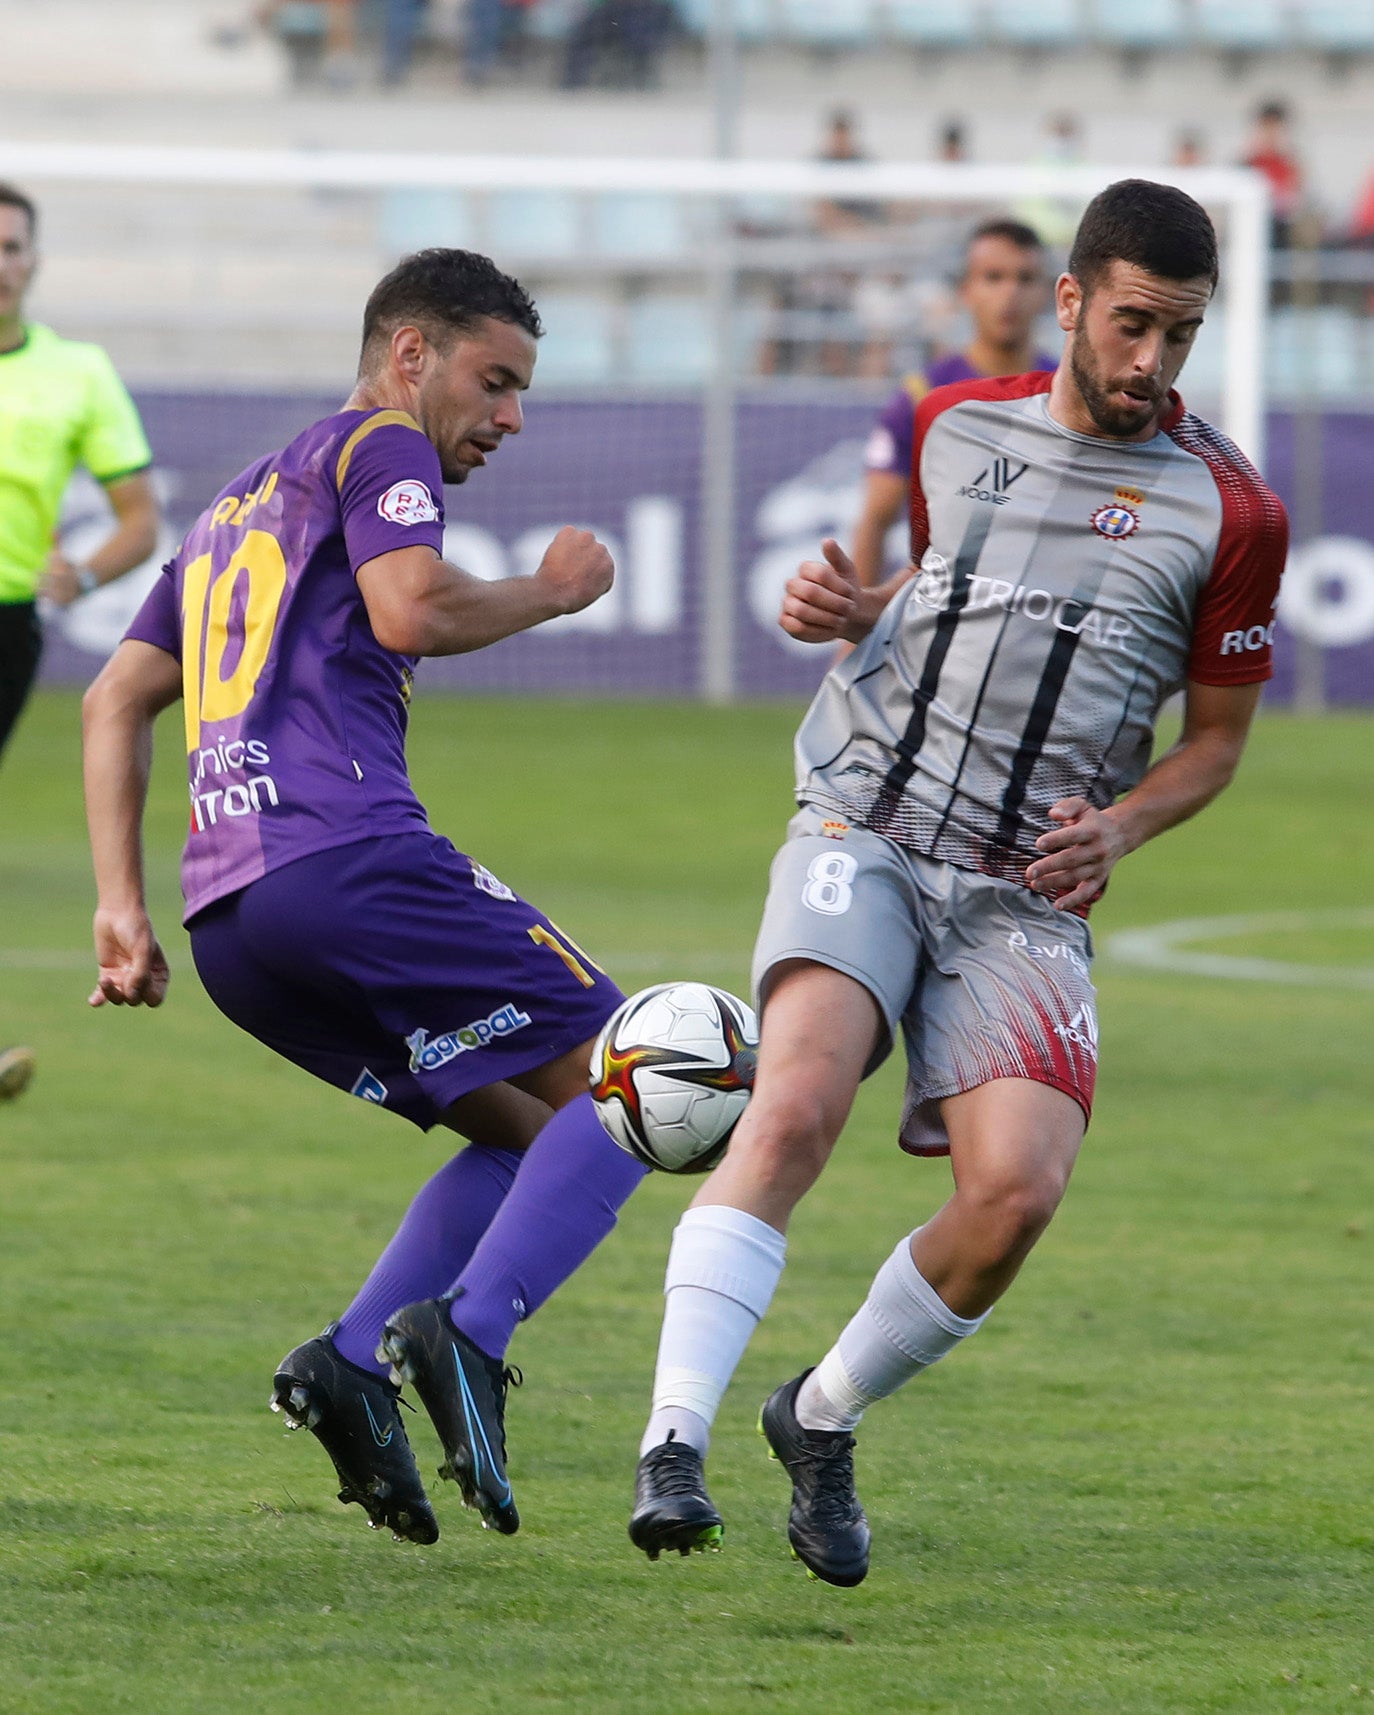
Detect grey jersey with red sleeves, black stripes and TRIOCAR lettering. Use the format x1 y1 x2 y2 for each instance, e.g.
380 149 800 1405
796 374 1288 882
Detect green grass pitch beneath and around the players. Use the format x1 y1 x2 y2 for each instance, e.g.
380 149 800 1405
0 693 1374 1715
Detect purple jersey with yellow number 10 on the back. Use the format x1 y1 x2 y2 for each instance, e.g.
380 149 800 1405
125 410 444 919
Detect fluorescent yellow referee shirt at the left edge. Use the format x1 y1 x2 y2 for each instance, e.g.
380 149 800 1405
0 322 153 602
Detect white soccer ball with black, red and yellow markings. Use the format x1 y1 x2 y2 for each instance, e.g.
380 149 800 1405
592 983 758 1173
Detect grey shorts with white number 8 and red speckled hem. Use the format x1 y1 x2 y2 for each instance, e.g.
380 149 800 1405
753 808 1098 1156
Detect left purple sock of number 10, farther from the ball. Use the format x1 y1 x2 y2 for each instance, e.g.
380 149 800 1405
334 1144 520 1375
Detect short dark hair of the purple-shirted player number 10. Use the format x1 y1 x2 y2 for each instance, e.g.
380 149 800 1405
360 249 544 365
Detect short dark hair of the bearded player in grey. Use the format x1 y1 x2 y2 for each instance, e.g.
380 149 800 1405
1069 178 1220 293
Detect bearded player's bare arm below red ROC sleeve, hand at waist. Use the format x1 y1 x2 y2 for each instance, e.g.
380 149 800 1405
1026 681 1263 911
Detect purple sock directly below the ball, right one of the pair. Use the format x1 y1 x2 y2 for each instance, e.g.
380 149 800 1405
449 1096 645 1358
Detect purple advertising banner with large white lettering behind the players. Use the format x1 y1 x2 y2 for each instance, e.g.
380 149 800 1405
43 393 1374 703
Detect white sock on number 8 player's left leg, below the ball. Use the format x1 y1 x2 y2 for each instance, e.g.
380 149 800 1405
640 1204 787 1458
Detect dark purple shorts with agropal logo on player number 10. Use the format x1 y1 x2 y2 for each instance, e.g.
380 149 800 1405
187 833 621 1127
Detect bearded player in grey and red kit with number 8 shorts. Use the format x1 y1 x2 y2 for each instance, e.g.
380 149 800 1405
630 180 1287 1585
